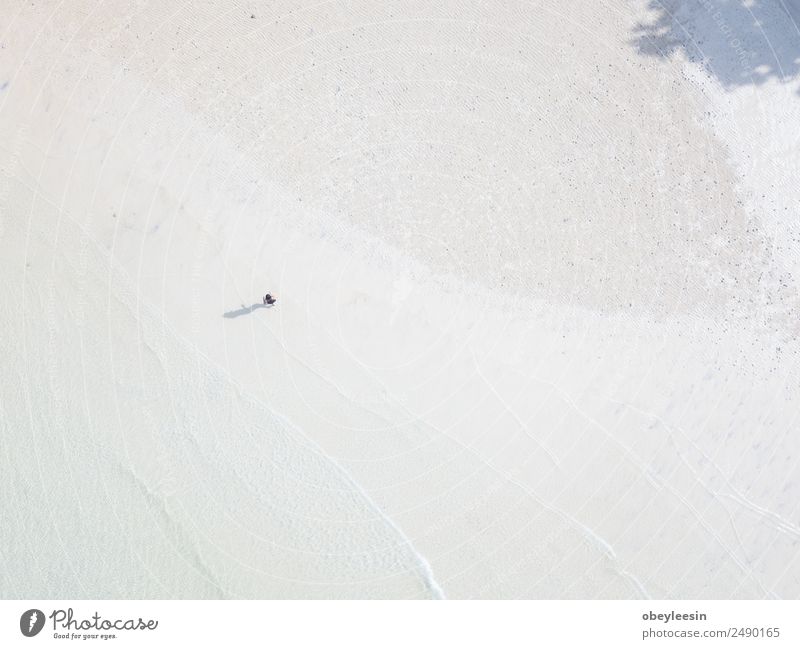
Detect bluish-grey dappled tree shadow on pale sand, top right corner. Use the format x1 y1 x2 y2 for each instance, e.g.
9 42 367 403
632 0 800 92
